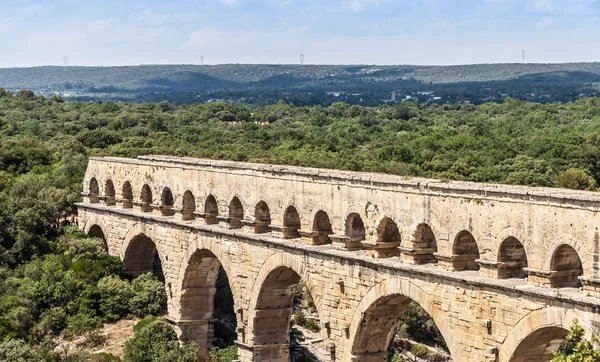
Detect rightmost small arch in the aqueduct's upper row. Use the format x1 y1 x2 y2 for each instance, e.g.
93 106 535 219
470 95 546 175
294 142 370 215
550 244 583 288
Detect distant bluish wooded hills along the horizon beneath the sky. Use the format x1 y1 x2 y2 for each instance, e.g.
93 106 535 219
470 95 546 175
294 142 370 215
0 63 600 106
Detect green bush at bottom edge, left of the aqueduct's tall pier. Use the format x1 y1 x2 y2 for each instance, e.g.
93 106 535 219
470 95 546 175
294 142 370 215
124 317 199 362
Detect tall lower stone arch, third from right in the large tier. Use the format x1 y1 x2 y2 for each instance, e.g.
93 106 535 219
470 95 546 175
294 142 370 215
245 253 327 361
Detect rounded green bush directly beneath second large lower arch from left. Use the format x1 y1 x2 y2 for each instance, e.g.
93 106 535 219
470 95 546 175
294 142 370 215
129 273 167 317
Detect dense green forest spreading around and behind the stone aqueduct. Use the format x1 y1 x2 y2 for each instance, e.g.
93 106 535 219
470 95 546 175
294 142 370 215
0 89 600 361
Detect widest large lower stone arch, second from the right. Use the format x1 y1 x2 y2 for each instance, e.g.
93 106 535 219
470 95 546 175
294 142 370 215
342 278 460 362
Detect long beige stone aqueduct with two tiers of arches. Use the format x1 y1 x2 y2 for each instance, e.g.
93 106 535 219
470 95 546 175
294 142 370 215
78 156 600 362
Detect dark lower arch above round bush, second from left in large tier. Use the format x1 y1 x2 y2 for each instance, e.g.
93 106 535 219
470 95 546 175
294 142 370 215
121 223 165 280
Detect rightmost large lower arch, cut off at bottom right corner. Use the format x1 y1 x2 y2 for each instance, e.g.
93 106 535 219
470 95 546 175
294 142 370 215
498 307 595 362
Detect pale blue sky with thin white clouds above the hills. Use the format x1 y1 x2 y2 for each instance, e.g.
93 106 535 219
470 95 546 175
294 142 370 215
0 0 600 67
